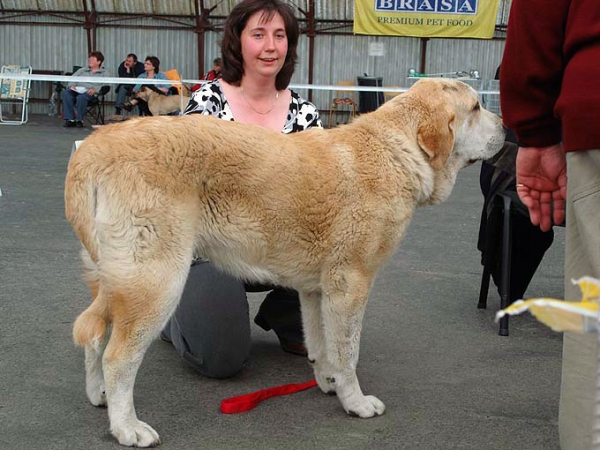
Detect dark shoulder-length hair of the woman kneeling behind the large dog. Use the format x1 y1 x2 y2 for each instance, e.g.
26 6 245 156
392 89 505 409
221 0 300 90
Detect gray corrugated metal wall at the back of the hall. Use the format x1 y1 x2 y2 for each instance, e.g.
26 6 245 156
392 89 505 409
0 17 504 114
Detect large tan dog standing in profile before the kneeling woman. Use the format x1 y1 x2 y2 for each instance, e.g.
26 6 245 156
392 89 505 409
65 79 504 447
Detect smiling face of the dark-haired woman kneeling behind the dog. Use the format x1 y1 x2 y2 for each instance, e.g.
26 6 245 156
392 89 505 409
241 11 288 81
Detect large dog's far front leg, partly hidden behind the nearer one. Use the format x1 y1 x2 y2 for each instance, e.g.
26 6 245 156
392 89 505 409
300 291 335 394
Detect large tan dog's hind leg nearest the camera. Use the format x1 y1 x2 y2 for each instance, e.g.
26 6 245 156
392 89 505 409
102 260 189 447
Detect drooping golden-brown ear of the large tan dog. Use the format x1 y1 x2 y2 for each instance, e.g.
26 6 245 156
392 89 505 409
417 105 455 170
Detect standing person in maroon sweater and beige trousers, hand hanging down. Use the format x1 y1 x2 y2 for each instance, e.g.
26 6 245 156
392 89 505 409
500 0 600 450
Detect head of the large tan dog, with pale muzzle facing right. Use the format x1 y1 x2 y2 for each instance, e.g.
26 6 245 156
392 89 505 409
392 78 505 203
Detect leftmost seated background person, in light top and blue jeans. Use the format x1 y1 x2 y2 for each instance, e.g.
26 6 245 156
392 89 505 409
62 52 106 128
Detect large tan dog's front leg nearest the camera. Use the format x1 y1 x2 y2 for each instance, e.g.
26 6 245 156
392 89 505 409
322 272 385 418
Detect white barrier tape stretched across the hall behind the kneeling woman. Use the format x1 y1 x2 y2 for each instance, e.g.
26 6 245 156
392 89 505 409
0 73 500 95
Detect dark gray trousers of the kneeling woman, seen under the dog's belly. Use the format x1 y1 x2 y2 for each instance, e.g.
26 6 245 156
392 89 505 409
163 261 303 378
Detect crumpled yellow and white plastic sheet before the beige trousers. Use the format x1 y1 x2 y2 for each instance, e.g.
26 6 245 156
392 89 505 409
496 277 600 333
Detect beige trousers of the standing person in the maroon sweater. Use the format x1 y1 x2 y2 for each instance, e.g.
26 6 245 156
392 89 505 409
558 150 600 450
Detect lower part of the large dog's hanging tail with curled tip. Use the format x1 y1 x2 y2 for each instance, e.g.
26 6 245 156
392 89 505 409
73 249 110 349
